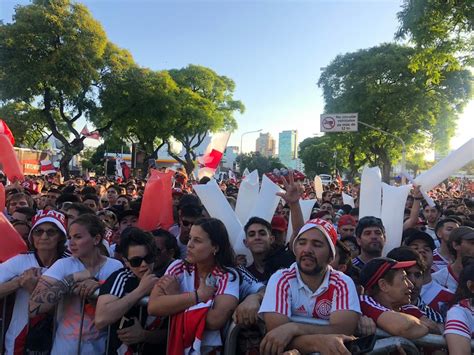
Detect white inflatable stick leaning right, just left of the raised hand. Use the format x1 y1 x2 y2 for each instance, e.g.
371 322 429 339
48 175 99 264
248 175 283 224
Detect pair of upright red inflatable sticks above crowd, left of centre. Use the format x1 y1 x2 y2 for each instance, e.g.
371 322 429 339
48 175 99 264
138 169 175 231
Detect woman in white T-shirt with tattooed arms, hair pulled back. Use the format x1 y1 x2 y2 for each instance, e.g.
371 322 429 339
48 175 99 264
29 214 122 355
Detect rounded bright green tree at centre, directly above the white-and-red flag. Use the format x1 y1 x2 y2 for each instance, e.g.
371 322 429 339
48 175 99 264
165 65 245 174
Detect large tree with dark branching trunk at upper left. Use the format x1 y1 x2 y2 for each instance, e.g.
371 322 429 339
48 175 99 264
0 0 133 177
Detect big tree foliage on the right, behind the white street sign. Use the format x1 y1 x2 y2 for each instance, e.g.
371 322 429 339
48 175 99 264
318 44 472 181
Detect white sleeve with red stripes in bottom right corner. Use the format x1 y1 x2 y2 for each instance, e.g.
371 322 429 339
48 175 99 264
444 299 474 339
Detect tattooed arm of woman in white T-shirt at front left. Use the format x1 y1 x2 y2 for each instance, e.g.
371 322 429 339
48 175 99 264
28 275 74 315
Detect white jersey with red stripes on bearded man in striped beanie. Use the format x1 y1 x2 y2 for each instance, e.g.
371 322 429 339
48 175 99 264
259 263 360 320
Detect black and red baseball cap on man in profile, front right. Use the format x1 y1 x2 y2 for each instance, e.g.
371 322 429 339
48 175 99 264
360 258 416 290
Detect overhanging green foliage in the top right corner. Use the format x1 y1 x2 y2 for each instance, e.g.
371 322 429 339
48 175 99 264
396 0 474 83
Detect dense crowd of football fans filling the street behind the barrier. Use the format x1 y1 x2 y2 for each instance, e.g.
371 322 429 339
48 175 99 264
0 171 474 354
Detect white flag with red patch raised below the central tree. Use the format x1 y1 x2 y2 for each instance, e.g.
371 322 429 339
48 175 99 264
198 132 230 179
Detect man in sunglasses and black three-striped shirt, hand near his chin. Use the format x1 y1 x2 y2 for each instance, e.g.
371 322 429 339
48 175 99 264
94 227 166 354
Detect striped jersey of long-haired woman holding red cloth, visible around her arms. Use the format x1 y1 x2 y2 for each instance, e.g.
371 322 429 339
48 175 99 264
165 259 239 350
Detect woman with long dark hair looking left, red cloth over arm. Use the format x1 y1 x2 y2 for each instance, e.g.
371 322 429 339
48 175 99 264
148 218 239 354
